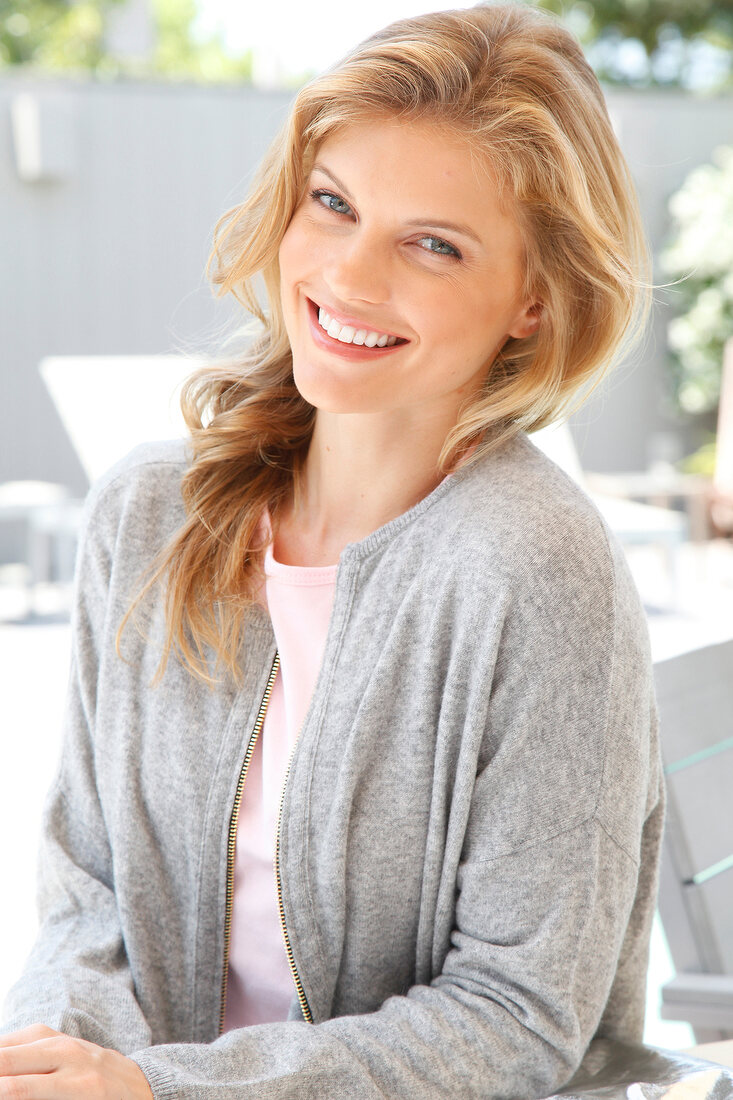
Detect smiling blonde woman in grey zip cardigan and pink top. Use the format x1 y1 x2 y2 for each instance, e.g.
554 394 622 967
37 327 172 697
0 6 661 1100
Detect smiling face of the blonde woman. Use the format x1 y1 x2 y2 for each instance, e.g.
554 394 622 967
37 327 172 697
280 119 538 422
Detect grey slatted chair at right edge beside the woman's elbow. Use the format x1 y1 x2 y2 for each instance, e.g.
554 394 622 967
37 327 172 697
655 638 733 1038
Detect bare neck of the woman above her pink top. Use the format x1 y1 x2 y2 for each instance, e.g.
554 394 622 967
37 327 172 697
274 410 460 565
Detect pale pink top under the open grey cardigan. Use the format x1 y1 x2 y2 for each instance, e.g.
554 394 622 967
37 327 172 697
225 547 338 1031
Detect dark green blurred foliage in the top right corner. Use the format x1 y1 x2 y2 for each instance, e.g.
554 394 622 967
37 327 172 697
537 0 733 90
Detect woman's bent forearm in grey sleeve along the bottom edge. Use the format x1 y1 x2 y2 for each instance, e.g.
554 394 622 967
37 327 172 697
125 828 651 1100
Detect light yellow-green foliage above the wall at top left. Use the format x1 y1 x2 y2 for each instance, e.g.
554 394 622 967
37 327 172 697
0 0 252 81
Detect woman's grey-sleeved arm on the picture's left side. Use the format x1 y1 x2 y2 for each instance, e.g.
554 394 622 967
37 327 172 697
2 484 151 1051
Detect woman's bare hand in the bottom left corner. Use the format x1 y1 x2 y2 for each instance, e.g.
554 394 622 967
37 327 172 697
0 1024 153 1100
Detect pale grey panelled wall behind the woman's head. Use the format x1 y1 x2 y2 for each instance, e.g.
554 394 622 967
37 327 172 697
0 75 733 510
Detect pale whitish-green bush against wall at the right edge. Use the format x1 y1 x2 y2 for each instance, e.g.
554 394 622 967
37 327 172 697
661 147 733 413
